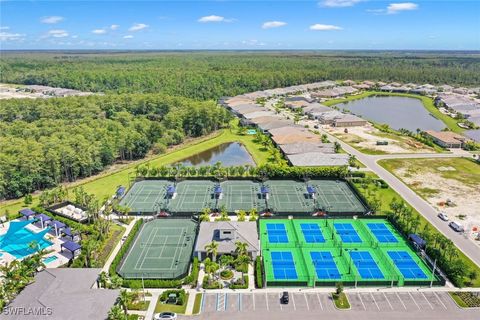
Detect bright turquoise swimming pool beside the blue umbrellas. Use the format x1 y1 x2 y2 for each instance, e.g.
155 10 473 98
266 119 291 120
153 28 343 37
0 221 53 259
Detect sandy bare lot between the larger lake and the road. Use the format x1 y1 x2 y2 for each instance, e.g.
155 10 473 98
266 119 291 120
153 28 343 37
326 124 435 154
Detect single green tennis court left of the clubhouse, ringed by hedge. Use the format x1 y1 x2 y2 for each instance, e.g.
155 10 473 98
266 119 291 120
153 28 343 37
118 219 196 279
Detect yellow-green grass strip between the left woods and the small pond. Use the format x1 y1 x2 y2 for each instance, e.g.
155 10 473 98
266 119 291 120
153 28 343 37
0 124 270 216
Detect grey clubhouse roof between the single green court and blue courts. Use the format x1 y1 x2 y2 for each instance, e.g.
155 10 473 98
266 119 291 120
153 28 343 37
195 221 260 254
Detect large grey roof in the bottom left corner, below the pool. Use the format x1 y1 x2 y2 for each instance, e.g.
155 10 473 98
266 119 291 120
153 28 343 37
8 268 119 320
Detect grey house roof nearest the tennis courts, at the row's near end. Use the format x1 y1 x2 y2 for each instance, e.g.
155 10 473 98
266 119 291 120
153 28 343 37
287 152 349 167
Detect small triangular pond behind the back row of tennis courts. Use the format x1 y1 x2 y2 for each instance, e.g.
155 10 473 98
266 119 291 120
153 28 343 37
173 142 255 167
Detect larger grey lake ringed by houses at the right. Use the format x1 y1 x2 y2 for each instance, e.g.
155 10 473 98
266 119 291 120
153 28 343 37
336 96 445 132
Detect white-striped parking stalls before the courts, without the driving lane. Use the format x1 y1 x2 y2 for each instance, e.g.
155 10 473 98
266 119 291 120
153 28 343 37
201 292 458 313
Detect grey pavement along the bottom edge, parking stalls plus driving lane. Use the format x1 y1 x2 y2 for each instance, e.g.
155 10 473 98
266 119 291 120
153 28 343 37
179 292 480 320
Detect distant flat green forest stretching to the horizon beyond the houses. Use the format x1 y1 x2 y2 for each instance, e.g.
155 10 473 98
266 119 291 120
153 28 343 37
0 51 480 100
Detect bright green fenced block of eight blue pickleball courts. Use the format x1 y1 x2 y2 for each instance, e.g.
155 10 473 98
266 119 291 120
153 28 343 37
259 218 441 286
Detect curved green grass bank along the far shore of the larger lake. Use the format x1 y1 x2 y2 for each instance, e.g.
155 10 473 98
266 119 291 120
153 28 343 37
323 91 465 133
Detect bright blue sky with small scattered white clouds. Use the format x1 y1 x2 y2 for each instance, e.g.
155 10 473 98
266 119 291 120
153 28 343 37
0 0 480 50
